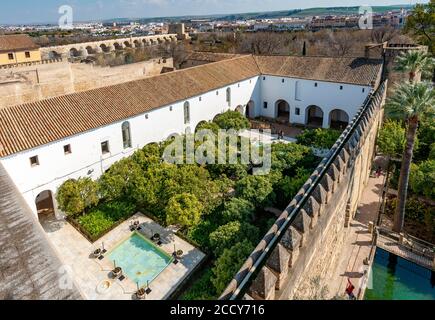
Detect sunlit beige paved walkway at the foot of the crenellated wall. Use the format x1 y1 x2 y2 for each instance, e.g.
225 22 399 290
328 176 384 298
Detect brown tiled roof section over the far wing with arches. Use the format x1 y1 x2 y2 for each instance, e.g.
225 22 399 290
254 56 382 85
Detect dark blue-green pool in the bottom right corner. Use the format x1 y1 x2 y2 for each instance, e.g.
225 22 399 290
364 248 435 300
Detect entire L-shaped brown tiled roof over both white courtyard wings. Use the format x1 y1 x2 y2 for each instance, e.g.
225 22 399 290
0 55 382 157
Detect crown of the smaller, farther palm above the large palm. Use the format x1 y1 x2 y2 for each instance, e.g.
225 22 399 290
395 50 435 82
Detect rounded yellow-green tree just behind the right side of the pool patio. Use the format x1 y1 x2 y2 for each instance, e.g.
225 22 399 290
166 193 203 228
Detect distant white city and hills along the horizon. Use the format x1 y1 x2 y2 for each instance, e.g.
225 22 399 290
0 6 412 37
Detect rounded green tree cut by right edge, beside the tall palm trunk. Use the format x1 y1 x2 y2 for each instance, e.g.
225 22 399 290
409 160 435 199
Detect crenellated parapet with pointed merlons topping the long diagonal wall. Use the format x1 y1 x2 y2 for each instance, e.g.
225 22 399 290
220 81 387 300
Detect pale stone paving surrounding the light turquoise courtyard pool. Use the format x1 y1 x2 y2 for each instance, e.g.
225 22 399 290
43 213 205 300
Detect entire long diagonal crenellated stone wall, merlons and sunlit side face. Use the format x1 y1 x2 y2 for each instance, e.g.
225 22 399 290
221 81 387 300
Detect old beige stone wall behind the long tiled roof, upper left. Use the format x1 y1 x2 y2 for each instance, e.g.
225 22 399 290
0 58 174 108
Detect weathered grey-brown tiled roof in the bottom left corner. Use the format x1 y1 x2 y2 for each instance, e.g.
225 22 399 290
0 164 81 300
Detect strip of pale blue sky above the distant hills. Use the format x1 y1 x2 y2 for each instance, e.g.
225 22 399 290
0 0 428 25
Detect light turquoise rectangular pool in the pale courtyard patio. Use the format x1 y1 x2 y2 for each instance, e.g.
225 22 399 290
108 232 172 287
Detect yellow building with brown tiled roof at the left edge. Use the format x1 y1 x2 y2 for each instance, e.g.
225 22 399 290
0 34 41 66
